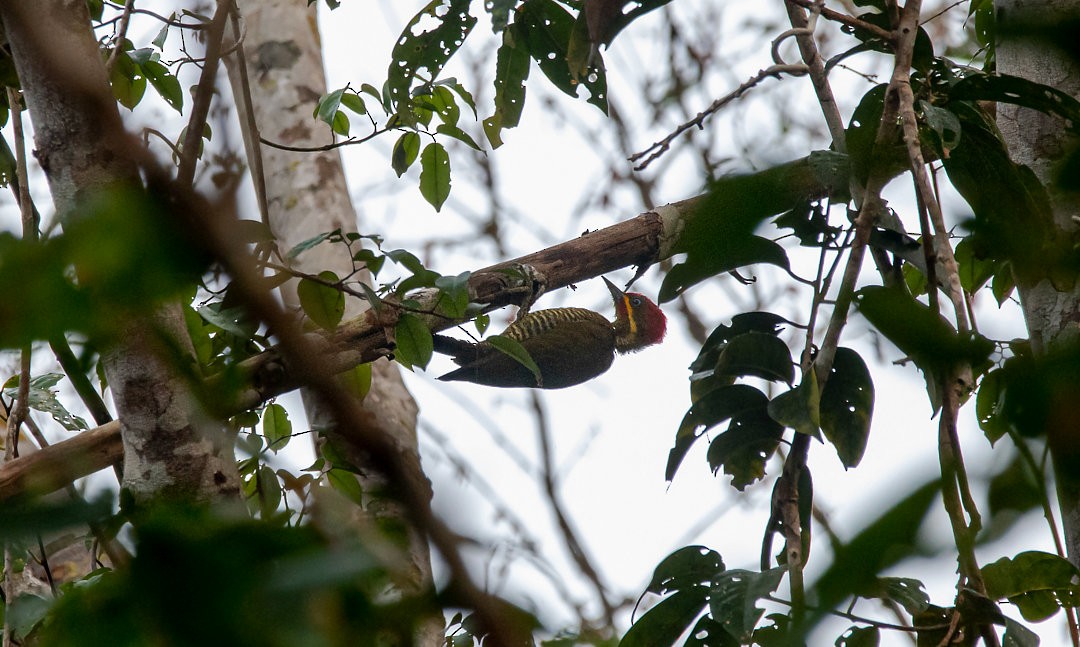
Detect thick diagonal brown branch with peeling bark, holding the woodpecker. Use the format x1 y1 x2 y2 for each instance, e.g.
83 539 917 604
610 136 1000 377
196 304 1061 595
0 150 859 501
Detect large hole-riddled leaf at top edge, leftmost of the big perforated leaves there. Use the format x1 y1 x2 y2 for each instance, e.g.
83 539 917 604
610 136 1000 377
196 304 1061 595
387 0 476 118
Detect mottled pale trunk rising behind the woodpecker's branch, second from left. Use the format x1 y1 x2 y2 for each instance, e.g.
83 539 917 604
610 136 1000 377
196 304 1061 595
229 0 443 646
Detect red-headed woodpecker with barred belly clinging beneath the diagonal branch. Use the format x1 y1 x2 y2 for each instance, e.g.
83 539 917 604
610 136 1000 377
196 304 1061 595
434 279 667 389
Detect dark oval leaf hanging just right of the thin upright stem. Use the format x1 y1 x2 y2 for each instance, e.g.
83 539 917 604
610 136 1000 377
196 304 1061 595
821 347 874 469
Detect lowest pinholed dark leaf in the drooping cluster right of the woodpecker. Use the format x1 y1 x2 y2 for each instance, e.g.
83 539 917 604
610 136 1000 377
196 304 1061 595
706 406 784 491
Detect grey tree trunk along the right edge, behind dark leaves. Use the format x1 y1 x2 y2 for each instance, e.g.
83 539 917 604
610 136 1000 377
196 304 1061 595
995 0 1080 565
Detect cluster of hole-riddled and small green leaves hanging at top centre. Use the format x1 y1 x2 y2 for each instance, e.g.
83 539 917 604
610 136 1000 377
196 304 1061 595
313 0 671 211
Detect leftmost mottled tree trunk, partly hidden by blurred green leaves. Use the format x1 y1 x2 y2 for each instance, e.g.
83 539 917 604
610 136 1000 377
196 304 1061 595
0 0 240 501
